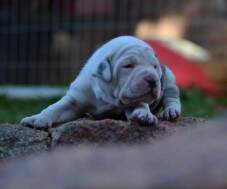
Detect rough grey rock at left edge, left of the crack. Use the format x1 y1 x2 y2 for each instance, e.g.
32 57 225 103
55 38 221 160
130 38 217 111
0 124 50 158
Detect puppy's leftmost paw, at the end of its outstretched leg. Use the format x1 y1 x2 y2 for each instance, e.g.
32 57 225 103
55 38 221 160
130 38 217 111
21 114 53 129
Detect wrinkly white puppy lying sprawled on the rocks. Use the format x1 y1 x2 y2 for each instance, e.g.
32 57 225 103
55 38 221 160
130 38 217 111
22 36 181 128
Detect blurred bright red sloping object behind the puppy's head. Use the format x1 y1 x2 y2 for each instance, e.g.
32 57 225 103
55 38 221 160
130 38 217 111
147 40 220 96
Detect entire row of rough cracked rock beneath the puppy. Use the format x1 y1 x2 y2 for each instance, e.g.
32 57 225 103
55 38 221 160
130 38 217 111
0 118 201 158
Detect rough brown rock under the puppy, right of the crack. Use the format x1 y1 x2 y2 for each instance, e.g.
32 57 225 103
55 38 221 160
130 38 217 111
50 118 202 146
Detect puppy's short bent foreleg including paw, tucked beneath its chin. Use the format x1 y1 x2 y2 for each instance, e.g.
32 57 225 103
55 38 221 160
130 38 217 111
125 103 158 125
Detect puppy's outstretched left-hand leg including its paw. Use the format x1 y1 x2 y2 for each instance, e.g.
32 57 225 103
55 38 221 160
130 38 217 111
21 96 78 128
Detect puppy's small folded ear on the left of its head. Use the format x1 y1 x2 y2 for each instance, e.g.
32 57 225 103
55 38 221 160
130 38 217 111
96 60 112 82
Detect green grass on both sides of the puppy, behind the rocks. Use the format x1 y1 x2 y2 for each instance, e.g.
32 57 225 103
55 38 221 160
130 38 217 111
0 90 227 123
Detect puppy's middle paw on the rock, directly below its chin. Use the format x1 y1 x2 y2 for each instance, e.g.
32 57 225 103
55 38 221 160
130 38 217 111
130 109 158 125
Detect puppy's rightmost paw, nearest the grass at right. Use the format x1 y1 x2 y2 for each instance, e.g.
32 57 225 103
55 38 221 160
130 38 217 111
158 106 181 121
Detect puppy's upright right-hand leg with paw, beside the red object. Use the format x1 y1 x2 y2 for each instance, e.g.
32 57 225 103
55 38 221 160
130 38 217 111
159 70 181 120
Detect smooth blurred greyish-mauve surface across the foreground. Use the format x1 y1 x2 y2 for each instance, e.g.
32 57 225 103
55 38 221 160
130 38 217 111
0 119 227 189
